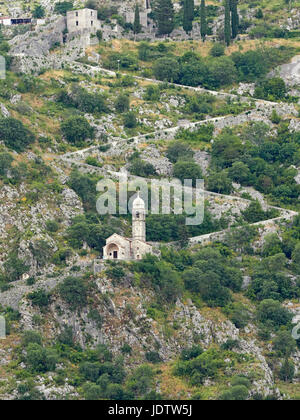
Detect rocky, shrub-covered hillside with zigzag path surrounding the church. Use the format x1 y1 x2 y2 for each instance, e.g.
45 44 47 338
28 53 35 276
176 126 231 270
0 0 300 400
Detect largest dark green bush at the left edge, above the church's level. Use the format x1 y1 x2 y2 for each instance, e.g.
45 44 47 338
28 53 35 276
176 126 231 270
0 117 35 153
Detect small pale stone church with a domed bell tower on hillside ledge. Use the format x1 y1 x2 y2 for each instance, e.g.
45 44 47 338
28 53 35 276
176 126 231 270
103 192 154 260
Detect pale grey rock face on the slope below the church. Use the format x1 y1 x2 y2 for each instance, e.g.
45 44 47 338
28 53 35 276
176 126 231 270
9 273 274 399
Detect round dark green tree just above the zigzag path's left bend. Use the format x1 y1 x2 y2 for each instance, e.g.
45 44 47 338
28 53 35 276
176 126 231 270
61 116 95 146
